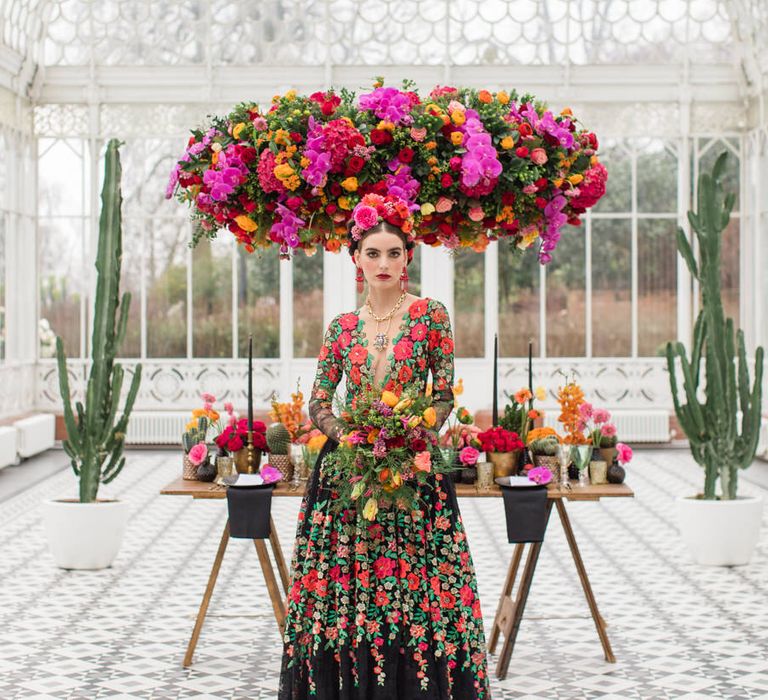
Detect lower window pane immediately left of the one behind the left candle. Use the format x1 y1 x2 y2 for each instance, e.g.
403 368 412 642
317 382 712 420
192 235 233 357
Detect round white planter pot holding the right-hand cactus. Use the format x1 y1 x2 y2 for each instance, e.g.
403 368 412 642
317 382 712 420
676 496 763 566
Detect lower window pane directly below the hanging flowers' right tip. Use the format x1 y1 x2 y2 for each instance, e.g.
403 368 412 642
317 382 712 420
592 219 632 357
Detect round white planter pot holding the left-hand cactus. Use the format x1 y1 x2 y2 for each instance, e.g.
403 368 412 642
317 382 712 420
42 501 128 569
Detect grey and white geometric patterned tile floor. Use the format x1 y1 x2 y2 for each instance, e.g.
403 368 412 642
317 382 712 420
0 450 768 700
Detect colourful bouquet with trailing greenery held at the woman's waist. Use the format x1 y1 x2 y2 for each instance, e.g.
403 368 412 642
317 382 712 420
323 388 449 520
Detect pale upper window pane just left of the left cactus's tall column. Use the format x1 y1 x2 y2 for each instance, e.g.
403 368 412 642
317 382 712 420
37 139 86 216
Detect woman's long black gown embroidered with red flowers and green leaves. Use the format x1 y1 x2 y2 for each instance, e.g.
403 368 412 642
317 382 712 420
278 299 490 700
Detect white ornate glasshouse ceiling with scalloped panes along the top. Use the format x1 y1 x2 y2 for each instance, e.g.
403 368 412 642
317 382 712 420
0 0 768 103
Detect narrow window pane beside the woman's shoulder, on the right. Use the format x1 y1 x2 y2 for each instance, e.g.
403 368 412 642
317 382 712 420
453 248 485 357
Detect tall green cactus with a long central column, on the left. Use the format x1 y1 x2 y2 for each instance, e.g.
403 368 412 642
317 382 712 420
56 139 141 503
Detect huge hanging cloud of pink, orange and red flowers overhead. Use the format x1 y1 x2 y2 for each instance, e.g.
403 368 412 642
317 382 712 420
166 80 607 263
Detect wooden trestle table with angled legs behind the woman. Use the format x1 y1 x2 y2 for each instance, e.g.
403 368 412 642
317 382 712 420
160 478 634 679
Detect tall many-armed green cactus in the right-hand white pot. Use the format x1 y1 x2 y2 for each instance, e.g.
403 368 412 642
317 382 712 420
667 153 763 499
